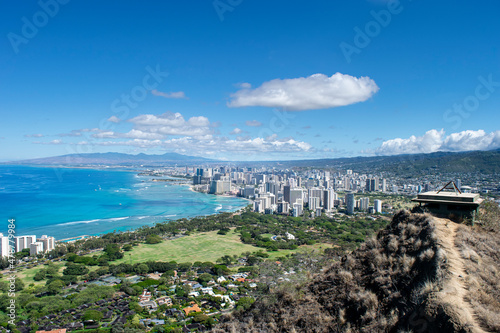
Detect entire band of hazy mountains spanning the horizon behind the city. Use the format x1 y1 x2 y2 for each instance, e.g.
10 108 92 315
4 149 500 175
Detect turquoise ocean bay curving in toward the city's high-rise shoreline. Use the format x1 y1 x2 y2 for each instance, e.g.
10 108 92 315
0 165 248 239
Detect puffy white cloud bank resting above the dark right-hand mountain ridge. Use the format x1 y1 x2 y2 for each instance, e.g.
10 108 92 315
375 129 500 155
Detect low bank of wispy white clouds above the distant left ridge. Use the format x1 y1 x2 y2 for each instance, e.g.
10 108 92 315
48 112 314 159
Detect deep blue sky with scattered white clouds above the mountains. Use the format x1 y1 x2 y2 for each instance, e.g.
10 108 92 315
0 0 500 161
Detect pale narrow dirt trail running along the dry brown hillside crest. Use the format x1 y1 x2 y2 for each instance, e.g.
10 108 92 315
436 218 487 333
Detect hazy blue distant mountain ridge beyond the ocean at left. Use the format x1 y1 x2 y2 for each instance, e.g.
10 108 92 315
4 153 215 166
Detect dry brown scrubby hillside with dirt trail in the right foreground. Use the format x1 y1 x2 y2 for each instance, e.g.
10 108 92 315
214 211 500 332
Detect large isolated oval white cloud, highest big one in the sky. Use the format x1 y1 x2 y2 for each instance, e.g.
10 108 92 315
227 73 379 111
